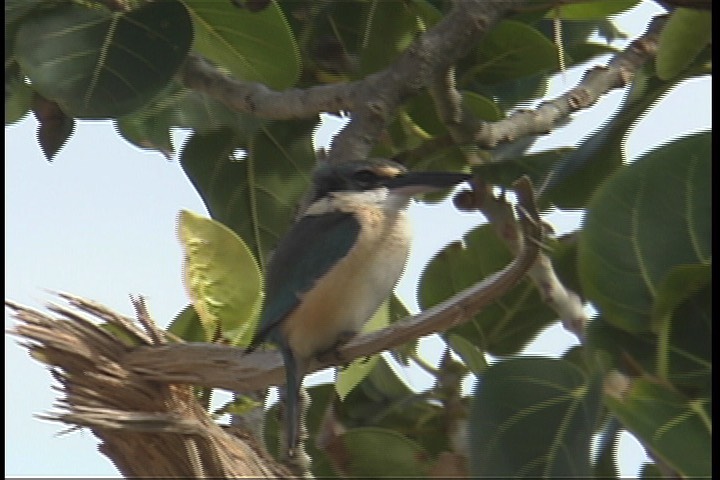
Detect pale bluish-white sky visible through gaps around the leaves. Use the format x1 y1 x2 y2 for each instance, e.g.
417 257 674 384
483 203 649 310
5 2 711 477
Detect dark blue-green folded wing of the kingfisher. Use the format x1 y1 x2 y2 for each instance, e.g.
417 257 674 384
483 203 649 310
251 212 360 348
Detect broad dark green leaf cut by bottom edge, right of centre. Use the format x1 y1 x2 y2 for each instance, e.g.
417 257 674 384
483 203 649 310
469 357 600 478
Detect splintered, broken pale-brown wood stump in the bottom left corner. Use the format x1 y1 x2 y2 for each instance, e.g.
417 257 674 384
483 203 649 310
6 294 288 478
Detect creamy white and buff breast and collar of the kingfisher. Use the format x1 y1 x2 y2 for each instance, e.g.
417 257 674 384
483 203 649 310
283 189 410 357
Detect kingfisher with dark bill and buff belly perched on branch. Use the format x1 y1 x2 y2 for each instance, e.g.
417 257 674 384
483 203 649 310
248 159 470 458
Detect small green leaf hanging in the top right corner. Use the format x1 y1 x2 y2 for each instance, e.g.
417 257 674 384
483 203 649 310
655 8 712 80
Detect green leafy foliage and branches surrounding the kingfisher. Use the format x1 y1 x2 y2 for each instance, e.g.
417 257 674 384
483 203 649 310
5 0 712 478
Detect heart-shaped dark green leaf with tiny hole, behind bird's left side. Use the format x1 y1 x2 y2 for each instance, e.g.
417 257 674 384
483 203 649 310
181 120 315 265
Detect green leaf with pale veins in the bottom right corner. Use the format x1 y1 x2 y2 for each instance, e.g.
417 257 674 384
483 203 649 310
605 378 712 478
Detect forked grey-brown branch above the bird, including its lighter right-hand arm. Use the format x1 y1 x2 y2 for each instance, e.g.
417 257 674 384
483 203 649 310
178 0 665 169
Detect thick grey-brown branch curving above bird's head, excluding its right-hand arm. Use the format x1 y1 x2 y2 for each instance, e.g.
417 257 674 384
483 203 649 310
178 0 528 162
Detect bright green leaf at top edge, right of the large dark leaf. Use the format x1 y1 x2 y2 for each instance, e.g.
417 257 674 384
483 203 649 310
183 0 300 90
